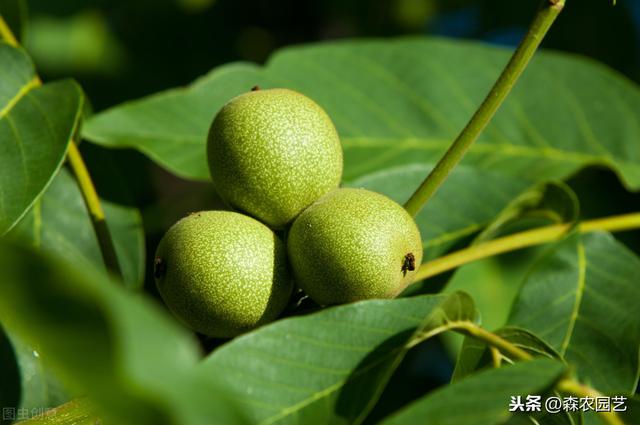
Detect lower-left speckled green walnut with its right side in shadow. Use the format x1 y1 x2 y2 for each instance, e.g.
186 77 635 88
154 211 293 338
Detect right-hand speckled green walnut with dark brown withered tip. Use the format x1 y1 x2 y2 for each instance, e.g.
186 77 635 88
287 189 422 305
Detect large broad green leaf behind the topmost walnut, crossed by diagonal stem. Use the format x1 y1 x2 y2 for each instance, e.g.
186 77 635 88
84 38 640 188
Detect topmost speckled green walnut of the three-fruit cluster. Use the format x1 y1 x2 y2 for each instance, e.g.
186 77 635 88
207 89 342 229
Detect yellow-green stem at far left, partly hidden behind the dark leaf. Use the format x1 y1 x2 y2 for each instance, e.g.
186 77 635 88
0 15 122 278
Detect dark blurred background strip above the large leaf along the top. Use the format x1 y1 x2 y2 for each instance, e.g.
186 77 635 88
15 0 640 110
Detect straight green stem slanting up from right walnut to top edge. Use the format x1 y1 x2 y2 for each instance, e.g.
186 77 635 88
404 0 565 216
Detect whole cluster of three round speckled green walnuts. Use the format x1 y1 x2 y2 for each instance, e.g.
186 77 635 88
154 88 422 338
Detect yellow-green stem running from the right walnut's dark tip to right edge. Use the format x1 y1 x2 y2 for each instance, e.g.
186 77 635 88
415 212 640 282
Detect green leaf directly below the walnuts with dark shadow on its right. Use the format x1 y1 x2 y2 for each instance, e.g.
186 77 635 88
200 293 475 425
